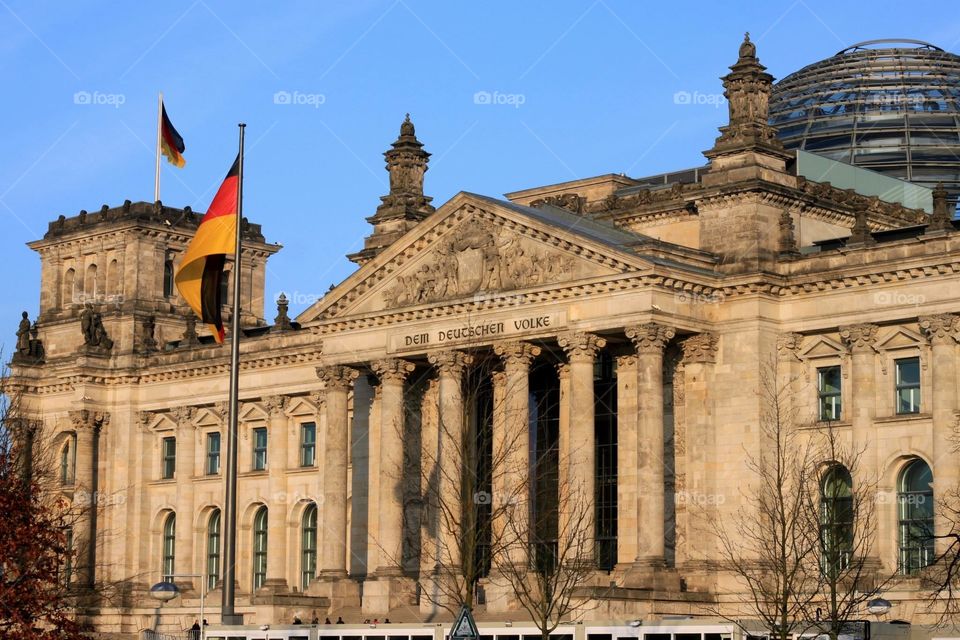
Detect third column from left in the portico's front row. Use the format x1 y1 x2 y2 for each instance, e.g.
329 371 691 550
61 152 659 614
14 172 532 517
427 351 475 571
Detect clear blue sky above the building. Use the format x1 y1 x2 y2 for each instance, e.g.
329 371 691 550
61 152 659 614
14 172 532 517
0 0 960 350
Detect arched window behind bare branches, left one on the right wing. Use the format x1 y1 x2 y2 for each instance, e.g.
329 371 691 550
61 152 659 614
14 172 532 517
820 464 854 577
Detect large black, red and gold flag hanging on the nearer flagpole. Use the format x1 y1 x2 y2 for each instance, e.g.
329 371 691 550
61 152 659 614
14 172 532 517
174 155 240 344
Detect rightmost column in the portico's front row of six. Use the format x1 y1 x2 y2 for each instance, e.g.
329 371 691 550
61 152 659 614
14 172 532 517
626 322 675 567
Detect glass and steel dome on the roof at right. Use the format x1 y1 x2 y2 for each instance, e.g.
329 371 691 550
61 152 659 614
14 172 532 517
770 40 960 200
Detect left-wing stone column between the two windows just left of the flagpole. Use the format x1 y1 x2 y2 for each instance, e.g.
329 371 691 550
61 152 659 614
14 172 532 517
172 406 197 590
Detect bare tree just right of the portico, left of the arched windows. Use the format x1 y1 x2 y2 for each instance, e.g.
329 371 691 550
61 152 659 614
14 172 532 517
711 364 819 638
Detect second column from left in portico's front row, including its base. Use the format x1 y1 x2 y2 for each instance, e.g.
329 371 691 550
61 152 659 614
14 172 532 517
362 358 414 614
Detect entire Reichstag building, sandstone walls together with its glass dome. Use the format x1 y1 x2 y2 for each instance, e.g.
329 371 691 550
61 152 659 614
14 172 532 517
11 39 960 633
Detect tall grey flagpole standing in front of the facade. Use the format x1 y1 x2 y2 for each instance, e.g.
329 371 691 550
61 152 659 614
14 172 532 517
220 122 247 625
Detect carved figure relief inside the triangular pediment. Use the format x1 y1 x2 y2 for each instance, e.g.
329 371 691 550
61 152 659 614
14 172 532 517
384 221 574 307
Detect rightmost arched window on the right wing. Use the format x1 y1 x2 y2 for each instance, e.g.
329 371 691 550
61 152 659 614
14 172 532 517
897 460 933 575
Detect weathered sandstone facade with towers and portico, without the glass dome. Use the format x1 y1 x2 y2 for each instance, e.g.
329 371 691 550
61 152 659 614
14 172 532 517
12 36 960 632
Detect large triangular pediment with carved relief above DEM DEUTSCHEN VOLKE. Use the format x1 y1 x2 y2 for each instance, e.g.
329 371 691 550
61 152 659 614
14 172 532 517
298 193 652 323
